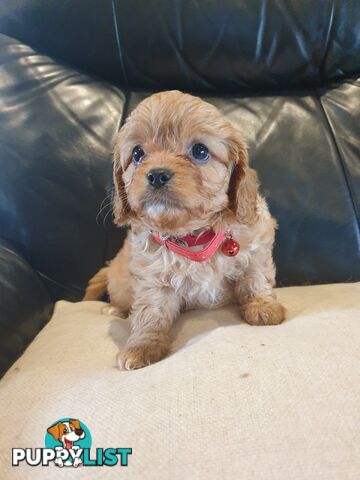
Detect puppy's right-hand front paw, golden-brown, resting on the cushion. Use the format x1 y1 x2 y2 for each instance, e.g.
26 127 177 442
240 295 286 325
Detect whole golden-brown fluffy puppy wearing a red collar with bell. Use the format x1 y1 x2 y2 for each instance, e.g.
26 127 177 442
85 91 285 370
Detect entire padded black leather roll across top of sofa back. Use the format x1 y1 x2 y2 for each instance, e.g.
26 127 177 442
0 0 360 92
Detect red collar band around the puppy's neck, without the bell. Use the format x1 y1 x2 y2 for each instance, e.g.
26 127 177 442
152 230 225 262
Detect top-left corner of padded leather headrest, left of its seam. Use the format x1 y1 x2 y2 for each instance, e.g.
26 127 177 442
0 0 122 83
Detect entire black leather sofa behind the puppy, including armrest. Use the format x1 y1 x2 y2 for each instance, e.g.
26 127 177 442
0 0 360 372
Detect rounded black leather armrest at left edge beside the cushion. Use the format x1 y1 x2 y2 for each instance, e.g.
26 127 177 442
0 239 53 375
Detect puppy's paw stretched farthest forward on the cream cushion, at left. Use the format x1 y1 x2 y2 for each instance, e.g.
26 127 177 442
117 342 169 370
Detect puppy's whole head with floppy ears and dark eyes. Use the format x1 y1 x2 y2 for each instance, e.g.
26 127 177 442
114 91 257 234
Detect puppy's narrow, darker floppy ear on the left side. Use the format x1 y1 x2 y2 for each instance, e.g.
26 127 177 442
113 133 130 225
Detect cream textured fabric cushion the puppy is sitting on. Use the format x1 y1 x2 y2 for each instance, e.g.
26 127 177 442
0 284 360 480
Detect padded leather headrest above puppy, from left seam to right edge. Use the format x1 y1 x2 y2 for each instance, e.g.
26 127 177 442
114 0 360 92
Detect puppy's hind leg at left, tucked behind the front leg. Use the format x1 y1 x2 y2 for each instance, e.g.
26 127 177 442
107 239 133 317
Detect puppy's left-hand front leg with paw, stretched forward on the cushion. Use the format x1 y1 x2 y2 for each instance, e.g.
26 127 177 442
117 288 180 370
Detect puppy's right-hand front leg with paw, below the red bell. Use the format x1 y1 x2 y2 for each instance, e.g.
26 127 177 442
235 249 286 325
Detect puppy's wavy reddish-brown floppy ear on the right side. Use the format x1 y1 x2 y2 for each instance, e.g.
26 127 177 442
228 133 259 225
